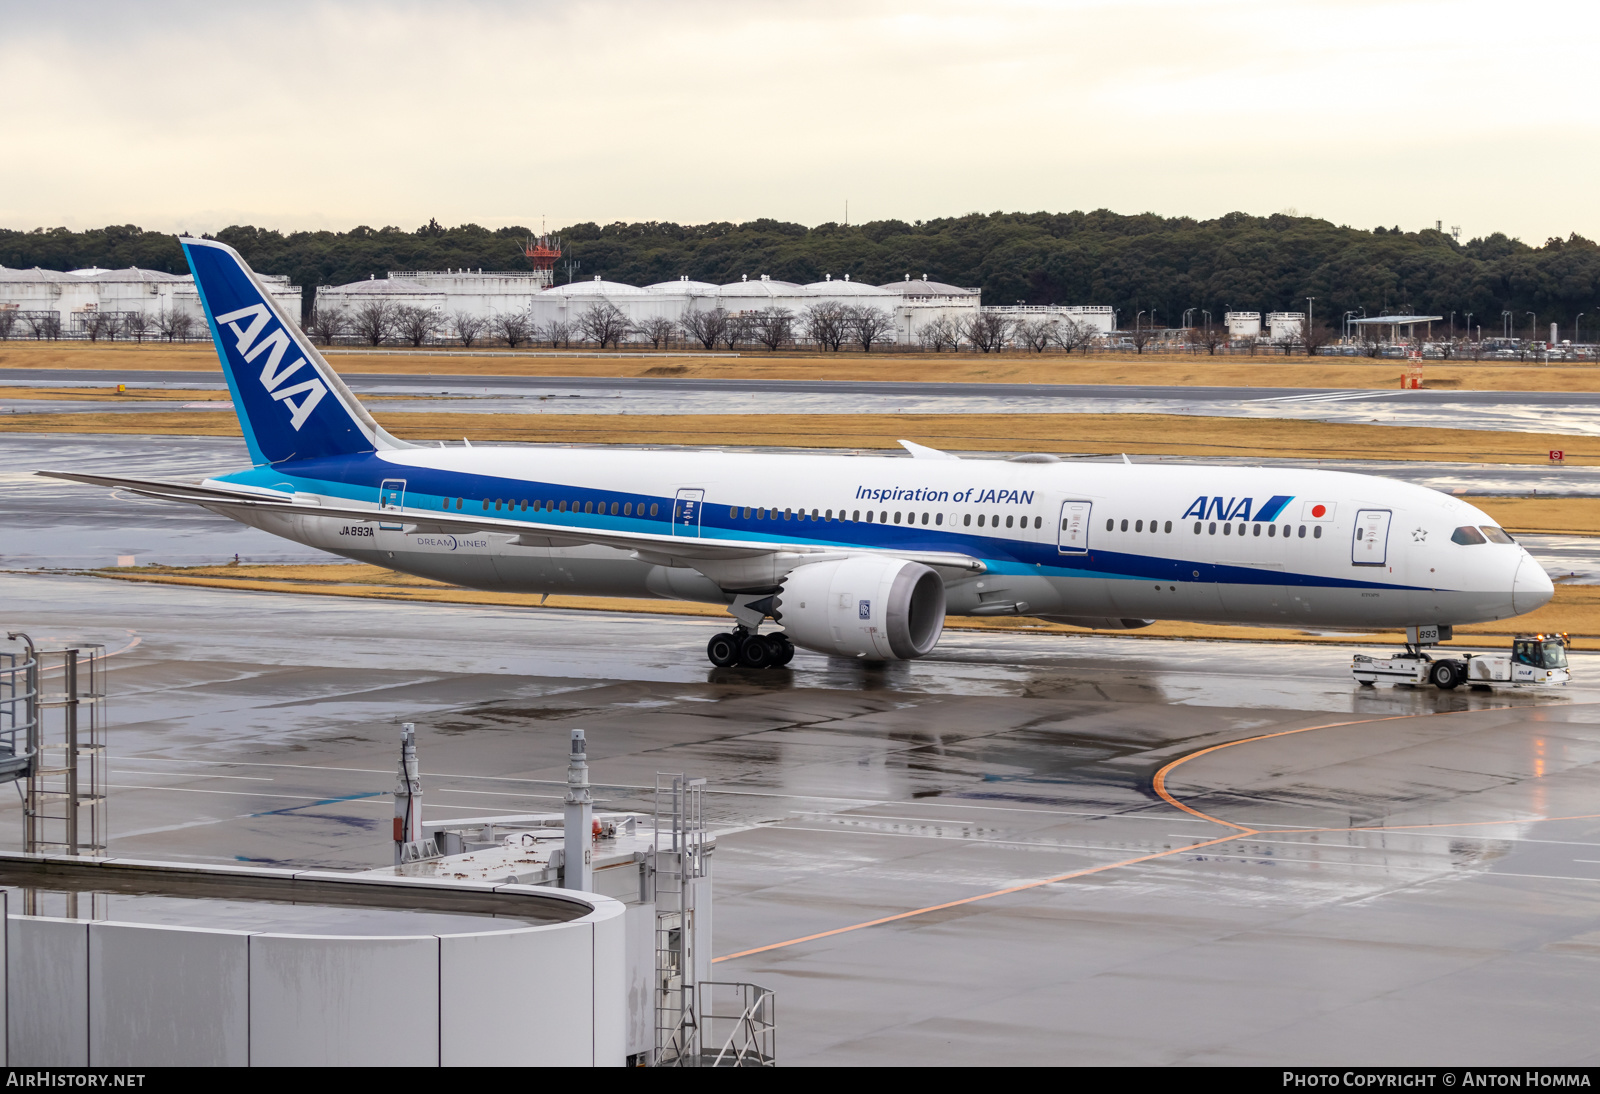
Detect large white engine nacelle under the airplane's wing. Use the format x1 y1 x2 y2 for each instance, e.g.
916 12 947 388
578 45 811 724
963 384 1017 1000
778 558 944 661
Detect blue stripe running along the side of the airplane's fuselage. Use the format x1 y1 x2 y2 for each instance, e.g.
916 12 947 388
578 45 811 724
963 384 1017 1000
218 453 1416 590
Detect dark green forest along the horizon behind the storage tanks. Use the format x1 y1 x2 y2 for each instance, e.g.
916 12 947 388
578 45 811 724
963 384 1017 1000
0 210 1600 336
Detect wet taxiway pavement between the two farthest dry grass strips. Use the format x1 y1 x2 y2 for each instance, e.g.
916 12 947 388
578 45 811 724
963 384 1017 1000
9 365 1600 437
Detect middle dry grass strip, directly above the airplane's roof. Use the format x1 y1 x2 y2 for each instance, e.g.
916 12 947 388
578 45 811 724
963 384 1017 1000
0 409 1600 464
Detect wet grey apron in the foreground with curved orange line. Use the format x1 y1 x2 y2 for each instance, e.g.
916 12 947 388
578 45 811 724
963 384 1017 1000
0 574 1600 1065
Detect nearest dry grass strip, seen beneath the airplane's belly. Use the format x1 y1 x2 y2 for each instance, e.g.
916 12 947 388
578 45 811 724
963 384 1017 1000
93 563 1600 646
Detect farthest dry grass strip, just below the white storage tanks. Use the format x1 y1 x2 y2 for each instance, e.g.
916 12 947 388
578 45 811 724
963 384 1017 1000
0 339 1600 392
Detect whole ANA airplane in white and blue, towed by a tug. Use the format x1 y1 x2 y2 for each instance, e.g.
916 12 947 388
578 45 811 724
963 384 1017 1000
38 237 1554 669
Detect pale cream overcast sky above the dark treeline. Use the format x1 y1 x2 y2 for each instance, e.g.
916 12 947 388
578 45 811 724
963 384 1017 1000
0 0 1600 243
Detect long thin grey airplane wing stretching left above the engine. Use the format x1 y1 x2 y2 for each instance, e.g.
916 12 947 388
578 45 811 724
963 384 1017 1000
34 470 987 574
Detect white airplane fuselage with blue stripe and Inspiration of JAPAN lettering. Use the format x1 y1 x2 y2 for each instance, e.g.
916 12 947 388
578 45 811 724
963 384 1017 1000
218 448 1550 629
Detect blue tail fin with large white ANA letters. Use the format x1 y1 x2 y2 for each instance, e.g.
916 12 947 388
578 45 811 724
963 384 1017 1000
179 237 408 465
